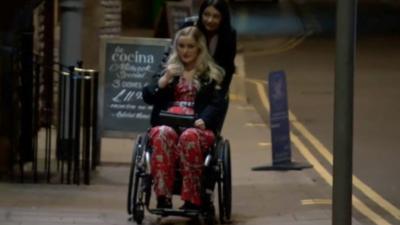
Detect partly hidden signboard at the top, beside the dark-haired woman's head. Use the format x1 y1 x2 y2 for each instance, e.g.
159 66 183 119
166 1 192 38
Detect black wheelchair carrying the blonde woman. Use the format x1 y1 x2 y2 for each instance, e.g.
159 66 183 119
127 113 232 225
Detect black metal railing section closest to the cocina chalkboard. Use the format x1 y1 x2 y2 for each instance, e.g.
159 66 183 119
57 67 100 184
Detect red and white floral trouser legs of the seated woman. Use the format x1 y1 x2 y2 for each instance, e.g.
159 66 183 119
149 126 215 205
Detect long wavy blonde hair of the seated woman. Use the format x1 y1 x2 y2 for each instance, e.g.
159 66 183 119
166 26 225 89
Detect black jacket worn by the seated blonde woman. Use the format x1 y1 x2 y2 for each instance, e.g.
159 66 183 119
142 75 224 132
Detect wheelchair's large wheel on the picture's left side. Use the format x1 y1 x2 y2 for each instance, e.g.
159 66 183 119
127 135 147 220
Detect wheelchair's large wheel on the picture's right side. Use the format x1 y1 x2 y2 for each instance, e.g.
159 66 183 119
218 140 232 223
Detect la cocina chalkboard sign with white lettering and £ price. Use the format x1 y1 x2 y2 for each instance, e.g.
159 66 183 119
98 37 170 137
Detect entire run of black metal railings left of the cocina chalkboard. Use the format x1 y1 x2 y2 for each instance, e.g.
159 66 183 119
0 49 100 184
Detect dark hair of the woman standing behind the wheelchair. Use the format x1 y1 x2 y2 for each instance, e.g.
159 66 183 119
197 0 232 36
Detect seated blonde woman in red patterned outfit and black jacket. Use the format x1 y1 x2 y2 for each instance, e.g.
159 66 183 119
143 26 224 209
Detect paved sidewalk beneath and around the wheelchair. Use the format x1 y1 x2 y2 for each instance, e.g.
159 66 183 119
0 30 360 225
